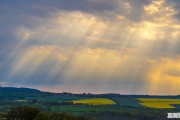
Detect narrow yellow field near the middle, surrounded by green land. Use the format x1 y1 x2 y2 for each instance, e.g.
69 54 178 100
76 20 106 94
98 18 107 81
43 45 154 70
72 98 116 105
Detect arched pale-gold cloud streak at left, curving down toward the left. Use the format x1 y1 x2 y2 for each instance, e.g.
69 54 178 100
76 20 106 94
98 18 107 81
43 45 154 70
10 45 67 76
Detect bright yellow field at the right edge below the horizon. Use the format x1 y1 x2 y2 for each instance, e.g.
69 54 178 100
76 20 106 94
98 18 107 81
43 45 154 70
137 98 180 108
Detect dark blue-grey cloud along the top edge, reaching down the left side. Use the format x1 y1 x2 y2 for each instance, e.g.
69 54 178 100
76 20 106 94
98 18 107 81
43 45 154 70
0 0 151 44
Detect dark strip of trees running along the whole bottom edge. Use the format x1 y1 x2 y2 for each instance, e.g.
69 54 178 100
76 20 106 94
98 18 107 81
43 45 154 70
0 106 167 120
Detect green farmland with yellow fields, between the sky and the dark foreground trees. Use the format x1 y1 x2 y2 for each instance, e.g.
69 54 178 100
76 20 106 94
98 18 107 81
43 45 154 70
0 88 180 120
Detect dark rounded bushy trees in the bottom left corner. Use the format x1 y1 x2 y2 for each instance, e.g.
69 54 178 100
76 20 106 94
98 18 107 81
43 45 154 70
0 106 96 120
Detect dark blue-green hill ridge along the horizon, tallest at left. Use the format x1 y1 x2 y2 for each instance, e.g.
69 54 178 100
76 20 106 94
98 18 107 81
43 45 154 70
0 87 180 100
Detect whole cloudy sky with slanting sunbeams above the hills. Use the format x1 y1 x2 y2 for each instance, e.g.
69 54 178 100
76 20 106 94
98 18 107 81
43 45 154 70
0 0 180 95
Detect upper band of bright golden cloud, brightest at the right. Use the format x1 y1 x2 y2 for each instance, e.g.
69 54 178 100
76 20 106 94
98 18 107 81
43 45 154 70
14 6 179 50
